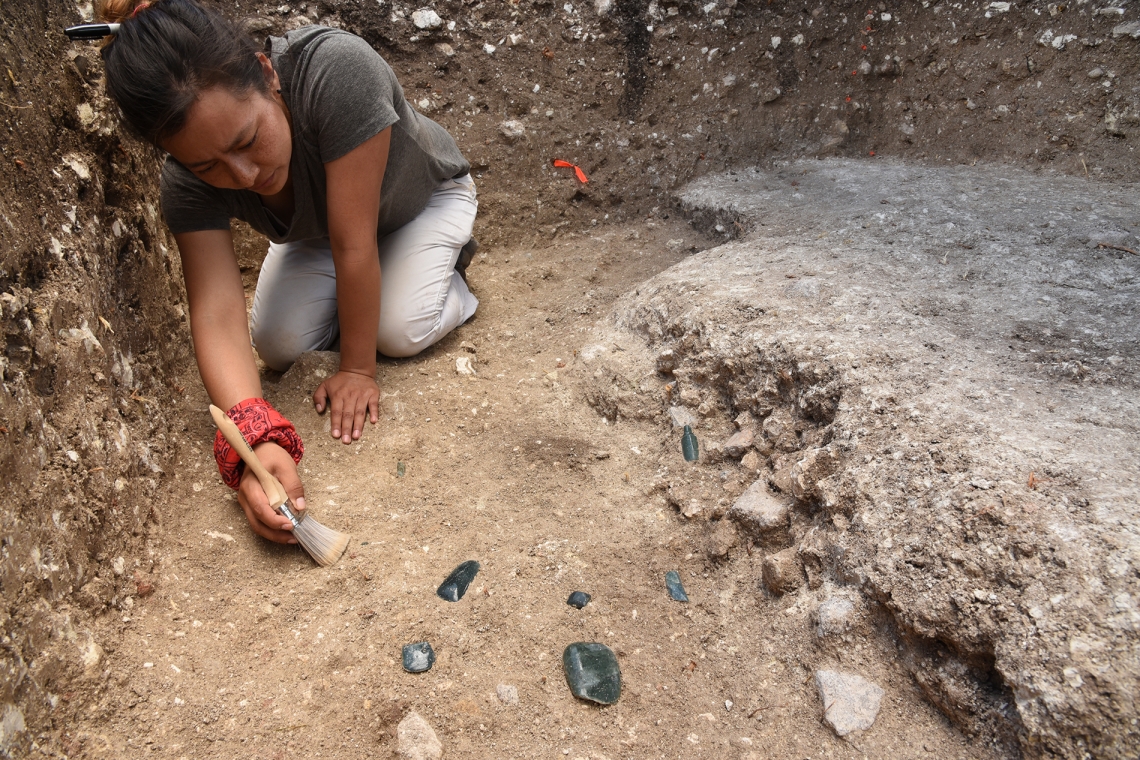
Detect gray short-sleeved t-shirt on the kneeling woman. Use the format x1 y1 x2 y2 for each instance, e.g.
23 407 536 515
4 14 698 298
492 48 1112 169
162 26 471 243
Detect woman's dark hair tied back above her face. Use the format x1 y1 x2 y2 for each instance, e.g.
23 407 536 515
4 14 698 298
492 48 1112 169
100 0 268 145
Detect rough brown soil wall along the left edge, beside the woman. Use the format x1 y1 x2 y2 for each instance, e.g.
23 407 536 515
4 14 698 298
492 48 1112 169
0 1 189 752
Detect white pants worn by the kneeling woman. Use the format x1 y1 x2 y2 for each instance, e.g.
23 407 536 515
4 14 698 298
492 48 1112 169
250 177 479 371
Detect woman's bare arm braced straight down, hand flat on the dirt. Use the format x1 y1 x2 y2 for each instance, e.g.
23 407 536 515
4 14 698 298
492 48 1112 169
312 128 392 443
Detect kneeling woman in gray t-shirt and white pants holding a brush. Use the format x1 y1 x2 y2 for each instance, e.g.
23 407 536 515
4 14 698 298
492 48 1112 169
93 0 478 542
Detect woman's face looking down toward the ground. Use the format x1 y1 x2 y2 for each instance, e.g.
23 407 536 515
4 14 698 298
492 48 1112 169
162 54 293 195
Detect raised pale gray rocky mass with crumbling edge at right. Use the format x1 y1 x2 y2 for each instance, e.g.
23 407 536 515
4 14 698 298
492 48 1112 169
583 160 1140 758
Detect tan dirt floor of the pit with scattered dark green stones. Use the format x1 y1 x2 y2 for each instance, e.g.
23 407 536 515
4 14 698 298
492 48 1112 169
62 222 992 758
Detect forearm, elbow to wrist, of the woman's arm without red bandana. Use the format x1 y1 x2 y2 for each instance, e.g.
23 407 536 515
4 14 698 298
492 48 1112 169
333 244 381 377
